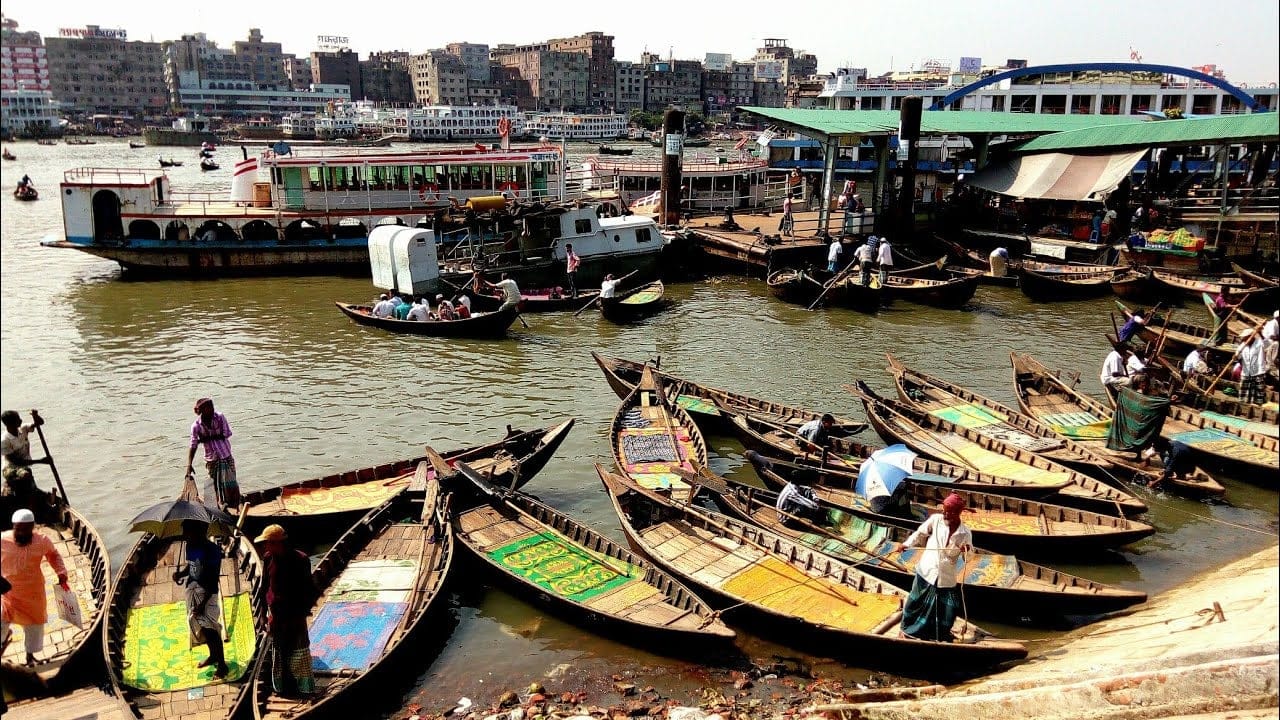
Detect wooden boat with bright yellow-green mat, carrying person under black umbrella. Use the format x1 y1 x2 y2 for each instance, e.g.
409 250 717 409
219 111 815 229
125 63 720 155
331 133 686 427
102 483 266 720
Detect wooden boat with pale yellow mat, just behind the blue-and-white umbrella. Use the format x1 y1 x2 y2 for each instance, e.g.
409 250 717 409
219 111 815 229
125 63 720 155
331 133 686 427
845 380 1147 516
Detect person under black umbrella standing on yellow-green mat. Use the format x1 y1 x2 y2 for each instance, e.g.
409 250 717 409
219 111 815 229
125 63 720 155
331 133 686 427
173 520 229 678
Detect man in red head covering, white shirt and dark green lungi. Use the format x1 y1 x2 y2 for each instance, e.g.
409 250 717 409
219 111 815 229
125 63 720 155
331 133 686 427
902 493 973 642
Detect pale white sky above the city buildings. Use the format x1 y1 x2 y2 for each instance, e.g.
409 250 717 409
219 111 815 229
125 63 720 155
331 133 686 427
5 0 1280 85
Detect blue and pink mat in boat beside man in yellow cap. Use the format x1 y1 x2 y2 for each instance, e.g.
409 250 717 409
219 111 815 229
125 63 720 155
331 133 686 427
310 601 408 670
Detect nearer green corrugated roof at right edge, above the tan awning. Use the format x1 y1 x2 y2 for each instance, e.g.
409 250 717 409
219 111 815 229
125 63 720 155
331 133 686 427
1018 113 1280 152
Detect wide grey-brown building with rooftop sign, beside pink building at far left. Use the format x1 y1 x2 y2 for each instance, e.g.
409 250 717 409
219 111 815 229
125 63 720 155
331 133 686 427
45 26 169 114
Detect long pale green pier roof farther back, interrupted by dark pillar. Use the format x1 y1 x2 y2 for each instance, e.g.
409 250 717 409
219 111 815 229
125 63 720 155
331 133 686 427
740 108 1148 136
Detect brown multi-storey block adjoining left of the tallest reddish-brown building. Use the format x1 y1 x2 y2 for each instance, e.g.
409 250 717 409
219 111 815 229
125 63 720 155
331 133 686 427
490 38 588 111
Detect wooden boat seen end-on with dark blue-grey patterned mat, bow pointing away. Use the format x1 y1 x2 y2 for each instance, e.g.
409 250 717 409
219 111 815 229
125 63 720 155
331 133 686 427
609 365 708 498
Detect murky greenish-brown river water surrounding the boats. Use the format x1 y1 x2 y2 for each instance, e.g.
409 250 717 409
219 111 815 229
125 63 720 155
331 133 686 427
0 140 1277 707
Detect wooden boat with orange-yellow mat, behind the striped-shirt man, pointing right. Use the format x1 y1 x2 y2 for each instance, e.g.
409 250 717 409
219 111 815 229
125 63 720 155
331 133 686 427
241 418 573 539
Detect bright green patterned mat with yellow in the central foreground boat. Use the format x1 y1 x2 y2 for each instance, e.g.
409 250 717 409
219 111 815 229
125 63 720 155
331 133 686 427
489 532 643 602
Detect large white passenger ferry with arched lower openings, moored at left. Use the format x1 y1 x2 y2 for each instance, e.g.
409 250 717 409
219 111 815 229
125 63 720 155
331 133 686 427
44 145 608 275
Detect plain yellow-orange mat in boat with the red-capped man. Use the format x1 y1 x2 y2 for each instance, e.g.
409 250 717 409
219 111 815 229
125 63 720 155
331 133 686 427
721 557 900 632
